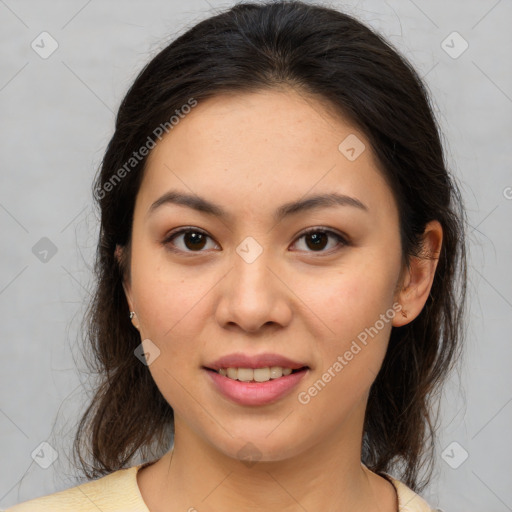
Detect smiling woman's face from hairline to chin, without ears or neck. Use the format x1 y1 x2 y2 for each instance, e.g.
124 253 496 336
125 91 401 460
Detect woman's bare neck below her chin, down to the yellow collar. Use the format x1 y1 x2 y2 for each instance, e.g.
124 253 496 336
138 406 396 512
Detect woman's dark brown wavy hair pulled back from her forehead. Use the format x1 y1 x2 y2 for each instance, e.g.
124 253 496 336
73 1 466 491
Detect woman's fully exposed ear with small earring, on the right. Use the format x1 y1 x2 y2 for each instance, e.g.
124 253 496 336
393 220 443 327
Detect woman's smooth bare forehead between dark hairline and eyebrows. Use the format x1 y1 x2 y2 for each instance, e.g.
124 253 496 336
136 90 392 221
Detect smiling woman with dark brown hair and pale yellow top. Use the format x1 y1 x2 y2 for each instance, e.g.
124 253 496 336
5 2 466 512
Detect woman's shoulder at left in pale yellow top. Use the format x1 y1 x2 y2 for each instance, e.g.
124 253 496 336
5 465 148 512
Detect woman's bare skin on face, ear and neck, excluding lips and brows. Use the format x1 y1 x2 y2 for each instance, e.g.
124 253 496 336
117 89 442 512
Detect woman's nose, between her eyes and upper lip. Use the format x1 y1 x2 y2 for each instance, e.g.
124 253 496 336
216 243 293 333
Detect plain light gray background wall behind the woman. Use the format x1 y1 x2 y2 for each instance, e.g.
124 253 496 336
0 0 512 512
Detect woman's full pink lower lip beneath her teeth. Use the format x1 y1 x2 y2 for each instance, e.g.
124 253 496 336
204 368 308 405
